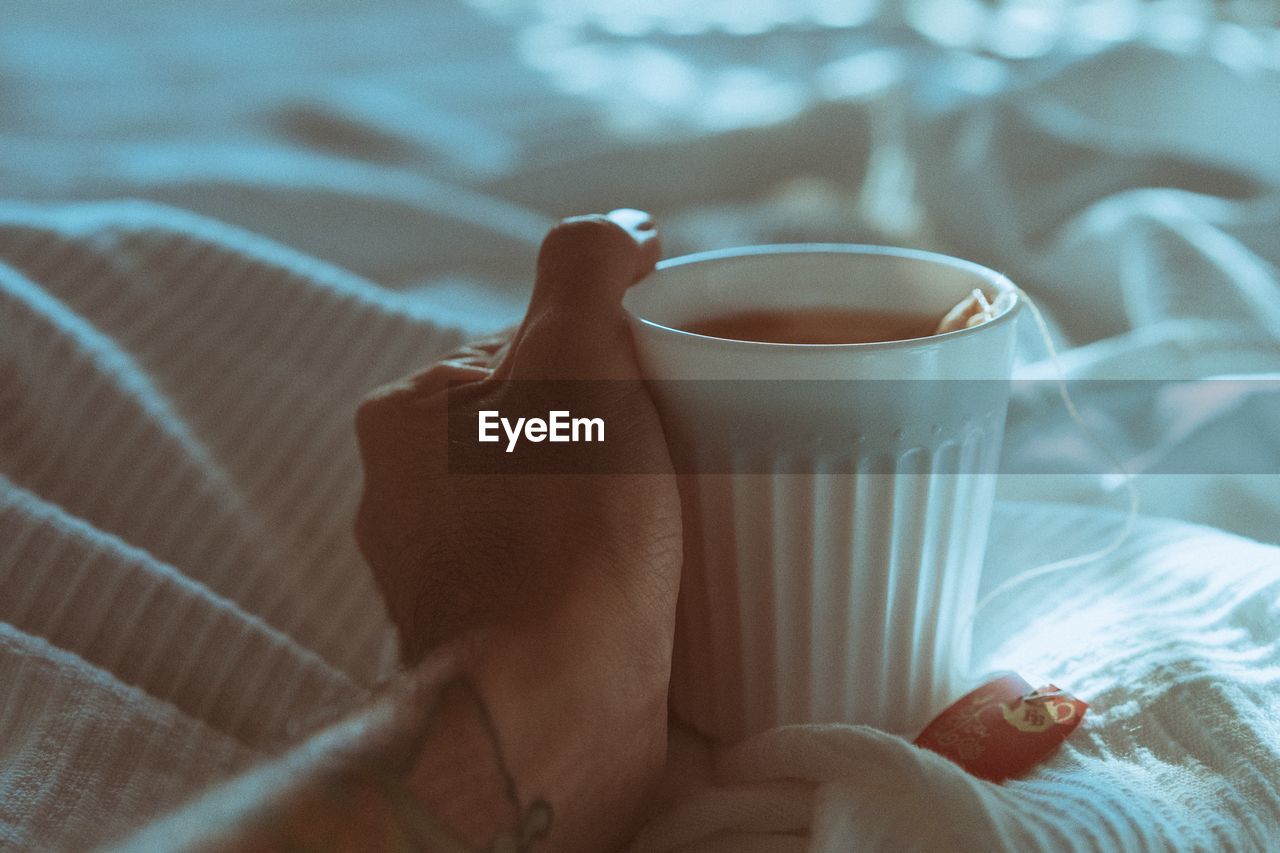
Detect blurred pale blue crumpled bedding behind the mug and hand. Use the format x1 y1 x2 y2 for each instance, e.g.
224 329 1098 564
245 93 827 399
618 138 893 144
0 0 1280 539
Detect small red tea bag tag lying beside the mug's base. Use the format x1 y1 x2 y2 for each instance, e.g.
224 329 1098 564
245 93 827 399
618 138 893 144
915 672 1089 783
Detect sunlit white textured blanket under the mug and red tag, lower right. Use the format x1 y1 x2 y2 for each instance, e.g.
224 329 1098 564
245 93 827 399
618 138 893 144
635 505 1280 852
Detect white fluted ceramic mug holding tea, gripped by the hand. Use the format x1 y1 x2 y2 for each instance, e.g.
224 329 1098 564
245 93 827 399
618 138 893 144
625 245 1019 739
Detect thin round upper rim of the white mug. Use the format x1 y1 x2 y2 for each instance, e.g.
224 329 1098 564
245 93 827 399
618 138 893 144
623 243 1023 351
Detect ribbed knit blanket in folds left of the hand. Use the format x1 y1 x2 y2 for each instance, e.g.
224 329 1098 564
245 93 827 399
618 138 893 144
0 204 457 849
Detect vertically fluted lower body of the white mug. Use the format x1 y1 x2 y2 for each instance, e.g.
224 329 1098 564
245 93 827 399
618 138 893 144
671 418 1004 739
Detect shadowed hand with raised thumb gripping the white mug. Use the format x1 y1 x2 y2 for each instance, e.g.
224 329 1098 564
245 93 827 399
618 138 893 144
356 210 681 841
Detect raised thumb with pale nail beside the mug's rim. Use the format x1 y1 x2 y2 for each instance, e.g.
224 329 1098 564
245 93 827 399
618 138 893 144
494 209 660 379
